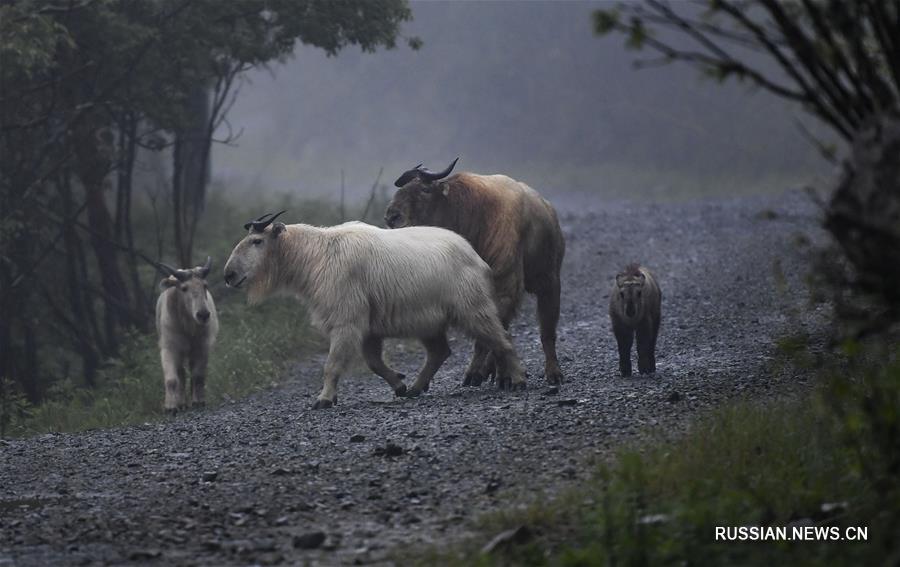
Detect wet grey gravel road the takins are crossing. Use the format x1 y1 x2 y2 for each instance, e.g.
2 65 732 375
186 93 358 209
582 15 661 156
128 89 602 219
0 193 818 565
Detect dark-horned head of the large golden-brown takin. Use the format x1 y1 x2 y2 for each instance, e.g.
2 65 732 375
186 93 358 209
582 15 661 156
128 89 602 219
384 158 459 228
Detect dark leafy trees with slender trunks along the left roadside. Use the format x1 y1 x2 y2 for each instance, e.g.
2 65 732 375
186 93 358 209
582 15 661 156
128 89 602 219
0 0 418 401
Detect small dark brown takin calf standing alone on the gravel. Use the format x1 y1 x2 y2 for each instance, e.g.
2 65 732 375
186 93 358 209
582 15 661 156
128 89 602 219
609 264 662 376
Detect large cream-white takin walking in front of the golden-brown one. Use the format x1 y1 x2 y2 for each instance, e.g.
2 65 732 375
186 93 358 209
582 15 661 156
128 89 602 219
225 211 525 409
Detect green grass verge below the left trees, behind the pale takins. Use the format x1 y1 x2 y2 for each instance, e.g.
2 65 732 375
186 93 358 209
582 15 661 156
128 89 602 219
0 191 385 437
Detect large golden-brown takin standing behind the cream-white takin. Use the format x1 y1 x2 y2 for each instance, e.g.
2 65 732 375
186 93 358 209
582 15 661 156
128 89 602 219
385 158 566 386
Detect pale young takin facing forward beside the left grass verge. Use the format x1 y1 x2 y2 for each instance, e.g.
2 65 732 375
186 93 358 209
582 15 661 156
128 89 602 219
156 257 219 413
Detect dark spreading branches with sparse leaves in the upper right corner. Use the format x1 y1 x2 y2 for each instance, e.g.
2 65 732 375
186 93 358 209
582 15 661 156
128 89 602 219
594 0 900 141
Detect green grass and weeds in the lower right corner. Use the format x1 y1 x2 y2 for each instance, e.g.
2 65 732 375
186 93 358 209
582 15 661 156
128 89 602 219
420 364 900 567
